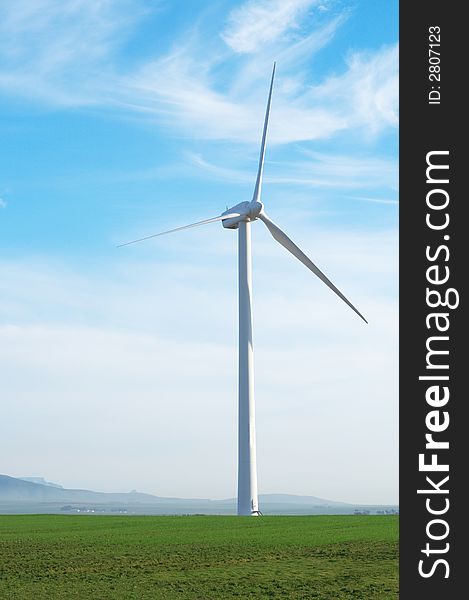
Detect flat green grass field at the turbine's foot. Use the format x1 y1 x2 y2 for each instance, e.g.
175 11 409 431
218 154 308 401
0 515 398 600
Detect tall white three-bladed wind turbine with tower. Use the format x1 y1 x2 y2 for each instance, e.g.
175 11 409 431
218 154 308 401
119 63 367 515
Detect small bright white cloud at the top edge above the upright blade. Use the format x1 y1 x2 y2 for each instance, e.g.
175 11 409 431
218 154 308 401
222 0 319 53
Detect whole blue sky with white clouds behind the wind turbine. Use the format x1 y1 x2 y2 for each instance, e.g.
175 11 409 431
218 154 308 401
0 0 398 502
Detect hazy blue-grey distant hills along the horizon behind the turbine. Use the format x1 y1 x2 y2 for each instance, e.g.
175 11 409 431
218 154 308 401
0 475 397 514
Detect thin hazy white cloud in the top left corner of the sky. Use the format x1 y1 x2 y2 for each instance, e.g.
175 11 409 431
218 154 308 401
0 0 148 106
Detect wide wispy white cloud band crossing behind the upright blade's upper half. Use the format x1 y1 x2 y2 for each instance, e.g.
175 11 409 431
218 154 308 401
122 40 398 144
